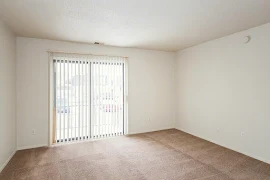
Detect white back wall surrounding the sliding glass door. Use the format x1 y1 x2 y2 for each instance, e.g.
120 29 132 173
17 37 175 149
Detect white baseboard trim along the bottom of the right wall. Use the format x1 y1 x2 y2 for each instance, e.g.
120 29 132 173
175 128 270 164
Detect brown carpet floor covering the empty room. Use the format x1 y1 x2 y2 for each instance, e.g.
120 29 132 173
0 129 270 180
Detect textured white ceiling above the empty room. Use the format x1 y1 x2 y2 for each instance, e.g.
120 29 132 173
0 0 270 51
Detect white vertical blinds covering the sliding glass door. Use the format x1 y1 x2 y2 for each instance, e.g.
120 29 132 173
53 55 125 143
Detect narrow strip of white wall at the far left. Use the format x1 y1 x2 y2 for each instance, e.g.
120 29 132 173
0 20 16 171
